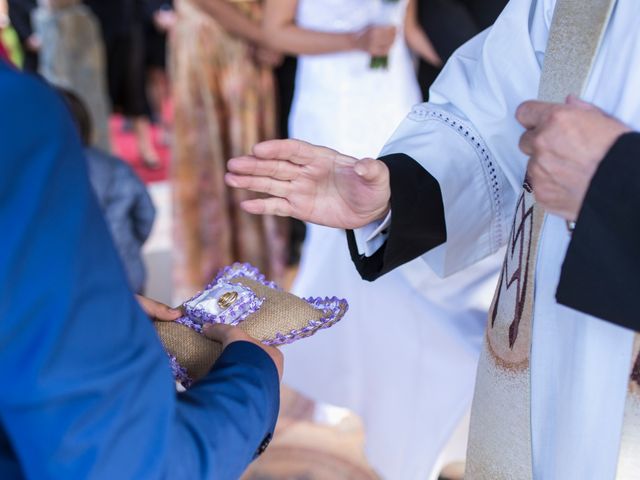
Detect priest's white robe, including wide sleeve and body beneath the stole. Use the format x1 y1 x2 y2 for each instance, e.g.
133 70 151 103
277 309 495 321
356 0 640 480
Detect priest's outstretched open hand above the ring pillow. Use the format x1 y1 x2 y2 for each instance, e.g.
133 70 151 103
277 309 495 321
225 140 391 229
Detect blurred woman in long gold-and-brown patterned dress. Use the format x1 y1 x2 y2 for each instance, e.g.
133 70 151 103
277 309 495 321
171 0 286 298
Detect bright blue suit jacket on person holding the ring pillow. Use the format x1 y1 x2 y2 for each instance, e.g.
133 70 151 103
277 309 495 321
0 61 279 480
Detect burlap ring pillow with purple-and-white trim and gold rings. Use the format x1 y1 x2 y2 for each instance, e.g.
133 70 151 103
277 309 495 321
154 263 348 387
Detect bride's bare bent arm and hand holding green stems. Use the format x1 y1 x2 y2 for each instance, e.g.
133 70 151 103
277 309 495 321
263 0 395 55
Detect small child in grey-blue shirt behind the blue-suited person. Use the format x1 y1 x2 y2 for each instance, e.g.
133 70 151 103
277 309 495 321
60 90 155 293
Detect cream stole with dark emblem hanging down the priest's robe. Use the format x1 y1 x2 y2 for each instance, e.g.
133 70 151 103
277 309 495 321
466 0 640 480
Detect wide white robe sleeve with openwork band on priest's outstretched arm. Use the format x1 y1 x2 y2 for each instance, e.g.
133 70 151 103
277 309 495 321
378 0 551 276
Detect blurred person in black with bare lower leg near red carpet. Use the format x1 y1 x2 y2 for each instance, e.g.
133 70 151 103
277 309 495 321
85 0 160 169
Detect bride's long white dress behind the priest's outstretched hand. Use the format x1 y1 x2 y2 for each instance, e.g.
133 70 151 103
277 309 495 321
284 0 499 480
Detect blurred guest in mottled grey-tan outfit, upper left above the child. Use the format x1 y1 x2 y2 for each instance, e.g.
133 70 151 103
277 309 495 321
33 0 111 152
